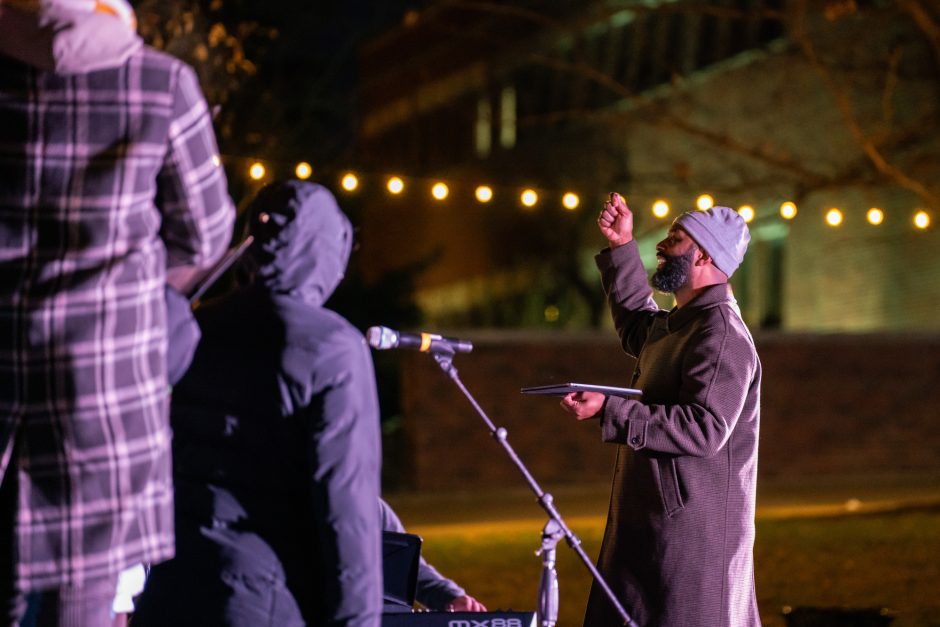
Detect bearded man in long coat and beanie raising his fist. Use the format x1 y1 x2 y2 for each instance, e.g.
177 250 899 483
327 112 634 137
562 194 761 627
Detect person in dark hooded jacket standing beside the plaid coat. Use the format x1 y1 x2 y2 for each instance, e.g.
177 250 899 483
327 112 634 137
133 181 382 627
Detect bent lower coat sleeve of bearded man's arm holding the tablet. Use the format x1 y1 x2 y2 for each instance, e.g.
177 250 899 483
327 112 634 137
601 317 757 457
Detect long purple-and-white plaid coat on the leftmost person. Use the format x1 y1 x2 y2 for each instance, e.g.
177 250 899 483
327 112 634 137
0 47 234 589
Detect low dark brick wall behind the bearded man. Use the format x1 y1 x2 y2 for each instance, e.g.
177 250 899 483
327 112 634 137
396 332 940 490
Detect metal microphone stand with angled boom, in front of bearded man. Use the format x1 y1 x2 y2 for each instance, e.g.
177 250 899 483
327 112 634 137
431 346 639 627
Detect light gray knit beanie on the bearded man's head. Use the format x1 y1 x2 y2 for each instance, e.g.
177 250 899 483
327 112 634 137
673 207 751 278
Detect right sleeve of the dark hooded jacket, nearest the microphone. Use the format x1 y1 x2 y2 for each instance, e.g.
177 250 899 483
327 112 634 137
308 330 382 627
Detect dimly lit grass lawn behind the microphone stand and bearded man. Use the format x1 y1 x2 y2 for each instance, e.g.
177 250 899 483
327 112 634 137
412 508 940 627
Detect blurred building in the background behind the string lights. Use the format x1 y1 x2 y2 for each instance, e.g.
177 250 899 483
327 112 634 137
357 0 940 331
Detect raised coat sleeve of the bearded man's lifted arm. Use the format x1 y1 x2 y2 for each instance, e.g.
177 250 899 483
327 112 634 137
595 241 659 357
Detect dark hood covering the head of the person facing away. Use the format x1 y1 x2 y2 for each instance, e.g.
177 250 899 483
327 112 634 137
245 181 353 306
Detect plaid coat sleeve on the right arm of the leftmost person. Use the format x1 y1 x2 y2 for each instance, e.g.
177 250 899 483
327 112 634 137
157 63 235 268
